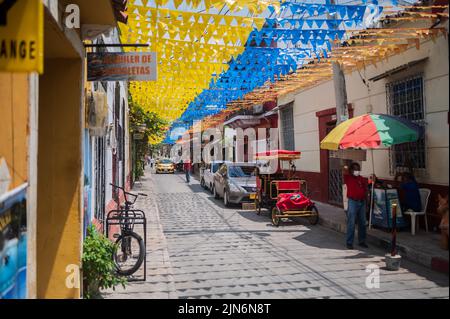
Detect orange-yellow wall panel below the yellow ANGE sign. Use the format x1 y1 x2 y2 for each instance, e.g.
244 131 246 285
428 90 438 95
0 72 29 190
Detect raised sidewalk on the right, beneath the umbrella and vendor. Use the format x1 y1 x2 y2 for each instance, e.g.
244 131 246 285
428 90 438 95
317 203 449 274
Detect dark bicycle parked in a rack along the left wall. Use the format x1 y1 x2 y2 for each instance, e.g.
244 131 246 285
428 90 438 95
110 184 147 276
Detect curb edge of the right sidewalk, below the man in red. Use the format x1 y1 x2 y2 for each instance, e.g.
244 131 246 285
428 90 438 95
319 217 449 275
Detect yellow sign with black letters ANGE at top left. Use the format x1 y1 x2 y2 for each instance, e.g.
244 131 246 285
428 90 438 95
0 0 44 73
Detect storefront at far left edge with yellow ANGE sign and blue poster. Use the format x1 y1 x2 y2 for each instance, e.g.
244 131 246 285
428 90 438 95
0 0 44 299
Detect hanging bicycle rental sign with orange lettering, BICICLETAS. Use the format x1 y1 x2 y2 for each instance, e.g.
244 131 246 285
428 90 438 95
87 52 157 81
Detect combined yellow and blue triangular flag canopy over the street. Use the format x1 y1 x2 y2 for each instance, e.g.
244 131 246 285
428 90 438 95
121 0 432 144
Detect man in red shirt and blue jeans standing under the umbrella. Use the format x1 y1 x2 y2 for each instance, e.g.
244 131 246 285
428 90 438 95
344 163 368 249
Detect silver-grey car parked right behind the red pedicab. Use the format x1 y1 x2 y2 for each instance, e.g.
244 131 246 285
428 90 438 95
213 163 257 206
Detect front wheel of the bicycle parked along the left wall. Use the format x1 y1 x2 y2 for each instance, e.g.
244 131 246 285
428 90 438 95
113 232 145 276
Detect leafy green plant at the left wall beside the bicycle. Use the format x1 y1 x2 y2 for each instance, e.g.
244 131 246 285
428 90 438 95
82 225 127 299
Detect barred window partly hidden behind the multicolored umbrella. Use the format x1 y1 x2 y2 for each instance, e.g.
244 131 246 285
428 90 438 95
386 75 427 175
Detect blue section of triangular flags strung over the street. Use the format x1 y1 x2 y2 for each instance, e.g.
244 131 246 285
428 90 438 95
165 2 382 139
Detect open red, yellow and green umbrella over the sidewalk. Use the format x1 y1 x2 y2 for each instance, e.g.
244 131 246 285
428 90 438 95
320 114 423 151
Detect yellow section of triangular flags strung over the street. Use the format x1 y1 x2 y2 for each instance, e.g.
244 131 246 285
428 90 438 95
121 1 280 120
